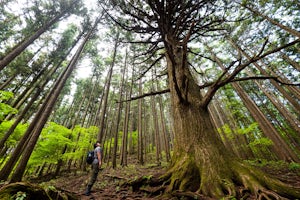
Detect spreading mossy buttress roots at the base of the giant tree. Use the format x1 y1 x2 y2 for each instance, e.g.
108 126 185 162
123 160 300 200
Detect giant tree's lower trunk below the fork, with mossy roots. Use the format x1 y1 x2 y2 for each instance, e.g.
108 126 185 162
165 89 300 199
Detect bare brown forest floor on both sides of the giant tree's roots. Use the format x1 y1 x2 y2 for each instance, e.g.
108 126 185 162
39 161 300 200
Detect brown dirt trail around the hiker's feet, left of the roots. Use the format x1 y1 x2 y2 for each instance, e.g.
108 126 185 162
47 167 164 200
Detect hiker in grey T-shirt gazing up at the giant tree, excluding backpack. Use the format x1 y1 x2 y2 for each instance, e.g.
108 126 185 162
85 141 102 196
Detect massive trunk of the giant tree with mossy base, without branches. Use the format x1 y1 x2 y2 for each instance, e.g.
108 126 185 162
163 37 300 198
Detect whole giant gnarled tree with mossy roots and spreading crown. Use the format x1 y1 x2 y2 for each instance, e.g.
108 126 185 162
102 0 300 198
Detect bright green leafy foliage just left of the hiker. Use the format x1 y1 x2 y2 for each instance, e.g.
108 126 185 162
28 122 98 171
